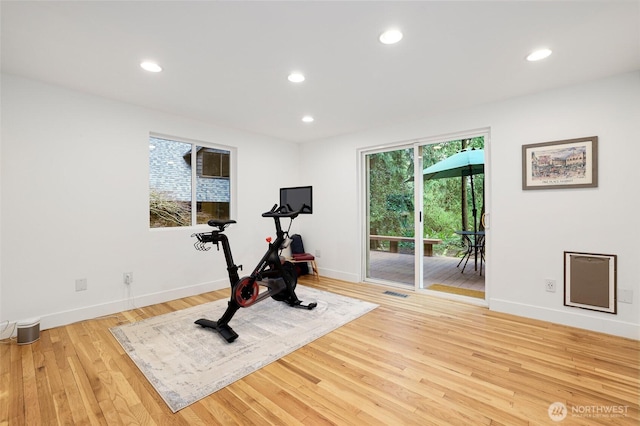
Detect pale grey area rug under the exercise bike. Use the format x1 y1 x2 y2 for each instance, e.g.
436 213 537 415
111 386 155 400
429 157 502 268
111 285 378 413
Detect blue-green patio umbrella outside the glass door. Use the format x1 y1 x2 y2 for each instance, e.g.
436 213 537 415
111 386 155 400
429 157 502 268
422 149 484 232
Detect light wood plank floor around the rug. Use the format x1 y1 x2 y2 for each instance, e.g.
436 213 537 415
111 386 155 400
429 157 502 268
0 278 640 426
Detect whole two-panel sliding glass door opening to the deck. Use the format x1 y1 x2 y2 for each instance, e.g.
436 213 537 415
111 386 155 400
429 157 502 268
361 134 485 297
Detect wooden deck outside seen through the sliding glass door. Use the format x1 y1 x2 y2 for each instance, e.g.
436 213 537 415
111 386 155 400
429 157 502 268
368 250 485 291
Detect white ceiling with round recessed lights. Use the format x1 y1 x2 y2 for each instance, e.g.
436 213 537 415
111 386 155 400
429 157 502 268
0 0 640 142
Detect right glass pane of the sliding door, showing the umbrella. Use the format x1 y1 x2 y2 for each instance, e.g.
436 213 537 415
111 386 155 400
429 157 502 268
421 137 484 297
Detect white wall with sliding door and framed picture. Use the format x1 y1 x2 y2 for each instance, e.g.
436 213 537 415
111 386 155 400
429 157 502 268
301 72 640 339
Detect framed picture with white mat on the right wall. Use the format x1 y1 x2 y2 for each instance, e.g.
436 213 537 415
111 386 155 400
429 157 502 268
522 136 598 189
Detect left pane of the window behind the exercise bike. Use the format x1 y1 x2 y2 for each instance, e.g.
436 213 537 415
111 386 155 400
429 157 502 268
149 137 191 228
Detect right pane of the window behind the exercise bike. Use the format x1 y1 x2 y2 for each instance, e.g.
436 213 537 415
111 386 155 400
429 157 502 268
196 146 231 224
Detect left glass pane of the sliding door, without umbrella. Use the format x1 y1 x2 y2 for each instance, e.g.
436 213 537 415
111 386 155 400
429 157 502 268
367 148 415 286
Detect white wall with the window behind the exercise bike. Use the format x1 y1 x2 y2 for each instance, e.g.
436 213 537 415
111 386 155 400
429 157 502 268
0 75 304 337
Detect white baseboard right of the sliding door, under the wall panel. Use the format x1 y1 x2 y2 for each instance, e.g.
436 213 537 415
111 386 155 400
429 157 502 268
489 299 640 340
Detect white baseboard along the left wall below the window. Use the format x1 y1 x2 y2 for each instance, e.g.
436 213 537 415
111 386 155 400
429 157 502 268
40 280 229 330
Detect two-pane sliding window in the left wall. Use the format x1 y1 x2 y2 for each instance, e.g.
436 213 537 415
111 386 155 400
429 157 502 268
149 136 232 228
